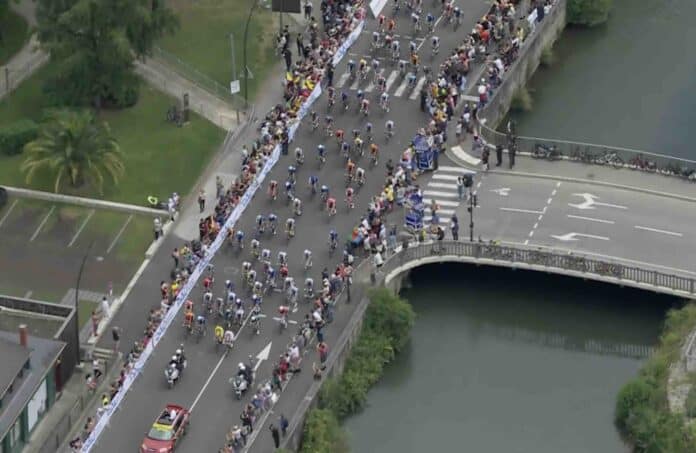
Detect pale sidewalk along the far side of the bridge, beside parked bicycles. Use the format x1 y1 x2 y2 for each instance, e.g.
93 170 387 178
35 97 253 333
447 134 696 202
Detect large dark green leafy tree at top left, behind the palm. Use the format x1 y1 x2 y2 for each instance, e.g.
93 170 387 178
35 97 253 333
37 0 178 109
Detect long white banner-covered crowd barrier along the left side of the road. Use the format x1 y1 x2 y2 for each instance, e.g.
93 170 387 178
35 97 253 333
82 21 364 453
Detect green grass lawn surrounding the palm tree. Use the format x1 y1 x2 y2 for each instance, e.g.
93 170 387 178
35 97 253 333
0 63 225 205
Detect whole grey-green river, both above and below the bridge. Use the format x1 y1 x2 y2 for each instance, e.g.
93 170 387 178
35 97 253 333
345 0 696 453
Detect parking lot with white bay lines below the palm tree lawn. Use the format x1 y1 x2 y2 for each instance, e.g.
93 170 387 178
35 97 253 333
0 198 152 303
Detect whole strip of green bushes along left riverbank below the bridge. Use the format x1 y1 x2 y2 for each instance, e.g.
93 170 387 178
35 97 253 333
300 288 416 453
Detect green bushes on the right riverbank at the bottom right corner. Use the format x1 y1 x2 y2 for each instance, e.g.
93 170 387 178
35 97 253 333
614 304 696 453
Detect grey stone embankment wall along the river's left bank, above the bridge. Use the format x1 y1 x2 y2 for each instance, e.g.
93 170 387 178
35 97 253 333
482 0 567 129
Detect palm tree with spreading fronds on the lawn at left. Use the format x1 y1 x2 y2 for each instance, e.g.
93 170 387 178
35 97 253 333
20 110 124 194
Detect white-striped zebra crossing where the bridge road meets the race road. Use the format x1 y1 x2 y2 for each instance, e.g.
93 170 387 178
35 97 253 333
423 165 476 226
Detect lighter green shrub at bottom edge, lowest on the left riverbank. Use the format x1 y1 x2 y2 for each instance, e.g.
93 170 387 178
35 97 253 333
300 409 350 453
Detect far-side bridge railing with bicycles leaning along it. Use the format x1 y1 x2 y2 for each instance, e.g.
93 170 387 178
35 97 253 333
479 124 696 181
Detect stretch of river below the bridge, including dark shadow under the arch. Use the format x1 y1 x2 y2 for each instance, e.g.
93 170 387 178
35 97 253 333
345 265 673 453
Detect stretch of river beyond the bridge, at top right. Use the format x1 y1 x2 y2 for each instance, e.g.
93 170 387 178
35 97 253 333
514 0 696 160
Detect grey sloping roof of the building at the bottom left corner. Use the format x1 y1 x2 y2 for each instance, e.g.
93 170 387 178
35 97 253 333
0 331 65 439
